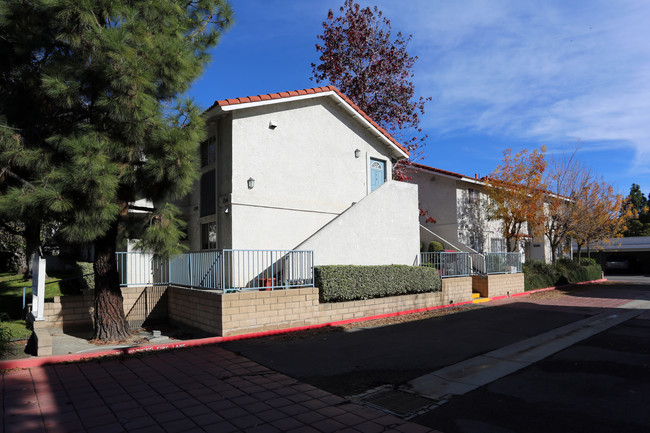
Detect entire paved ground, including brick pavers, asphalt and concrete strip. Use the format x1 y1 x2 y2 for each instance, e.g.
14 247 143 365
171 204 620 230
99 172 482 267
0 278 650 433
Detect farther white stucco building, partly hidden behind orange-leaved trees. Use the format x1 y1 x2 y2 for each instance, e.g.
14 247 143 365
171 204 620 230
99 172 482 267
412 164 551 262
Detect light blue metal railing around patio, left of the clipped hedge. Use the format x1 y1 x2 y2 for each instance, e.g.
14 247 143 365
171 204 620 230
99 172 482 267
117 250 314 292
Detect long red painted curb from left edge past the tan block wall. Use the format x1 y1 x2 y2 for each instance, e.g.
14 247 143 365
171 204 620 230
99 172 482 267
0 301 472 370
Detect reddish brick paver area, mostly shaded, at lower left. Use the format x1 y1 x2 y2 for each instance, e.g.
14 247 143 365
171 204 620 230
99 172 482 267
0 346 432 433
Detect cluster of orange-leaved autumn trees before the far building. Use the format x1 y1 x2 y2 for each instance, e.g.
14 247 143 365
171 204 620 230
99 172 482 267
486 147 629 262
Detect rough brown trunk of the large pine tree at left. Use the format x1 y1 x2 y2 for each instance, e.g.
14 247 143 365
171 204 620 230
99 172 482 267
93 222 129 341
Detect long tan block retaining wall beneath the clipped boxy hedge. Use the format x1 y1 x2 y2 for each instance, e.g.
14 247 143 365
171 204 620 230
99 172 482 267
168 277 472 336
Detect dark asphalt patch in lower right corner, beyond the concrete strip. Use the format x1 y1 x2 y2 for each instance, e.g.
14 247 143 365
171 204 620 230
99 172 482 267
412 319 650 433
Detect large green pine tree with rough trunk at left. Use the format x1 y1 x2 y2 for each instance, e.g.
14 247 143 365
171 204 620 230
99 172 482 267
0 0 232 340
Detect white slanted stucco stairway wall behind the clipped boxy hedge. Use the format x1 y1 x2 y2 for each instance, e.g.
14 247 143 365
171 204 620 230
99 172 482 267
296 181 420 265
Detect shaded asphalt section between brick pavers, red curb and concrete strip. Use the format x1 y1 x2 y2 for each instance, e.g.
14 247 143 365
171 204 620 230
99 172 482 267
222 302 588 396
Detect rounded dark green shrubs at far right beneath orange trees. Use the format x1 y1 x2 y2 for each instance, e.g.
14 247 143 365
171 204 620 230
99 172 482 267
523 259 603 290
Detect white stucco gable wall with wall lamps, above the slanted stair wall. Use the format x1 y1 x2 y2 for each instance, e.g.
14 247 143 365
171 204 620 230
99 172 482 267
220 98 392 249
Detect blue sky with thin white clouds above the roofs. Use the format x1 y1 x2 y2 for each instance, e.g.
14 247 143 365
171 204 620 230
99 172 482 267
189 0 650 195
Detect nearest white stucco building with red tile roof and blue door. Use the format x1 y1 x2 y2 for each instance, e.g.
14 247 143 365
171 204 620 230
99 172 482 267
180 86 419 264
